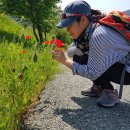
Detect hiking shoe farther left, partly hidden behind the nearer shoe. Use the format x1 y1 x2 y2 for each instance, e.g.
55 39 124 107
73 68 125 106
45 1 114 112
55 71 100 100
81 85 103 97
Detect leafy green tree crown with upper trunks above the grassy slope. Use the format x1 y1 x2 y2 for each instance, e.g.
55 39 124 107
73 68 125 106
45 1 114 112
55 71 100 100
1 0 60 41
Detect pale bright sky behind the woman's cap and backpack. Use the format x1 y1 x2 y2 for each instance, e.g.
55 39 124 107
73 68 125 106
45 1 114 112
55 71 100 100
59 0 130 13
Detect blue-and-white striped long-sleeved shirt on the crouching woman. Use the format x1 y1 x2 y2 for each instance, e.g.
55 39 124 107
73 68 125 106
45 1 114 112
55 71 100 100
72 25 130 80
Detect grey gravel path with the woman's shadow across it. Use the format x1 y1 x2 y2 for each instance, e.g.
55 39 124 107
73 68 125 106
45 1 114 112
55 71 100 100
22 63 130 130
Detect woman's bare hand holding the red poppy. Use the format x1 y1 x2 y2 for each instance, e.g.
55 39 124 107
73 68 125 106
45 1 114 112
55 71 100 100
52 49 66 63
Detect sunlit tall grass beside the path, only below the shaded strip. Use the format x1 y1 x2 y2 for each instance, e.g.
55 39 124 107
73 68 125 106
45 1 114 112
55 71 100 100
0 43 57 130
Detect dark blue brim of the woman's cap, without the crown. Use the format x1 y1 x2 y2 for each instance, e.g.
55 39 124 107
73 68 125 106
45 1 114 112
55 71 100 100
56 17 76 28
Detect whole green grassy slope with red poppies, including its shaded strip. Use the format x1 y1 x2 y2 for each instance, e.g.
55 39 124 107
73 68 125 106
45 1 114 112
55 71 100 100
0 11 61 130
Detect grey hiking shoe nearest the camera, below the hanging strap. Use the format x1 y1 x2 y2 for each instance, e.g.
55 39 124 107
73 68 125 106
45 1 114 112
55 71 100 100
97 89 120 107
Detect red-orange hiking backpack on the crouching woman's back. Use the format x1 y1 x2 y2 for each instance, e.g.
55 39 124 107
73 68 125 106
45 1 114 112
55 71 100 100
98 11 130 43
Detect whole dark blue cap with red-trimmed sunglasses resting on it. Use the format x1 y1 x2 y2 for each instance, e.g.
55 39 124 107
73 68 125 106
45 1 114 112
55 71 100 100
56 0 91 28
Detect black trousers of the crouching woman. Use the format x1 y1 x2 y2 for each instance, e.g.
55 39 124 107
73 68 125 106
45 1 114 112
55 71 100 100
73 54 130 89
